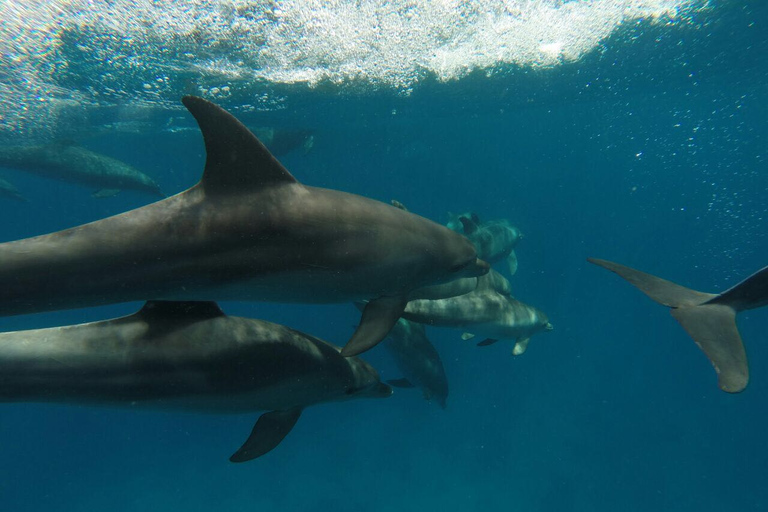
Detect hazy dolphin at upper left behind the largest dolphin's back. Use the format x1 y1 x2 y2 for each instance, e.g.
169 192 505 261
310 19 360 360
0 142 165 197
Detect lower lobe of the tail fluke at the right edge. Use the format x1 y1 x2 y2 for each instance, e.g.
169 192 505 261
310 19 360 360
672 304 749 393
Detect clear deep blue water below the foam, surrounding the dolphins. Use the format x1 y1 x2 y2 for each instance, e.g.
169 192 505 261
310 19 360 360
0 1 768 512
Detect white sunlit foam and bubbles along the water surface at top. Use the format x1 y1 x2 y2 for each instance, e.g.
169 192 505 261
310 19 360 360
0 0 707 138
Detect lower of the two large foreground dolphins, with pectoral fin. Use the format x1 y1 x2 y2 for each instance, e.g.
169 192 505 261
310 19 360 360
0 302 392 462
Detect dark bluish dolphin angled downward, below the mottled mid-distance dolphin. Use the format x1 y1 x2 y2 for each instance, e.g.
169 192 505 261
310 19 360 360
384 318 448 409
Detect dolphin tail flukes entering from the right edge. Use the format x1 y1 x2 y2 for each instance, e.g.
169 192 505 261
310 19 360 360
587 258 768 393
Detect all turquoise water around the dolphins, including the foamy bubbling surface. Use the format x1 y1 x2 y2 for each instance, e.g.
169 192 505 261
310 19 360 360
0 1 768 512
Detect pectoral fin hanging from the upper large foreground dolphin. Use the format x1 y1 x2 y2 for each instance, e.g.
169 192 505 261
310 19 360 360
341 297 408 357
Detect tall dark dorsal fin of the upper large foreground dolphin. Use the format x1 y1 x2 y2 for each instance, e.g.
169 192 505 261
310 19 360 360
181 96 296 193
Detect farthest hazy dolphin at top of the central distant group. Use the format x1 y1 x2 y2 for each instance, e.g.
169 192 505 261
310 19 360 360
459 216 523 275
